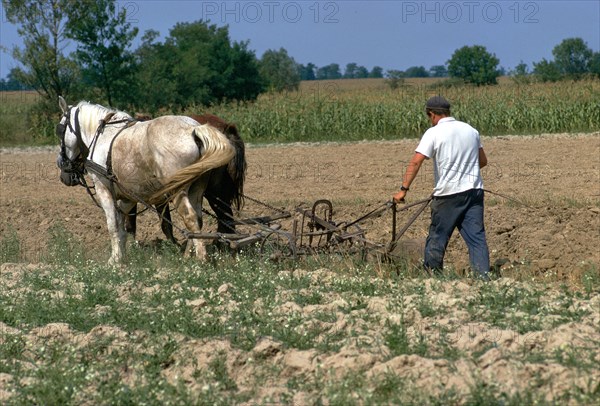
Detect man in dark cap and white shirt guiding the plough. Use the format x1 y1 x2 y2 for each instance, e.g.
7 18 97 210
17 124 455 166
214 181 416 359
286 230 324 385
393 96 490 280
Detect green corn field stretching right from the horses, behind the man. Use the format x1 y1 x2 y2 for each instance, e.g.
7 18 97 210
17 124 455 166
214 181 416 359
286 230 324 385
202 79 600 143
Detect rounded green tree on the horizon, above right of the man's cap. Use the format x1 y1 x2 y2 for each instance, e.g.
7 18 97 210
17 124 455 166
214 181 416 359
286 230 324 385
448 45 500 86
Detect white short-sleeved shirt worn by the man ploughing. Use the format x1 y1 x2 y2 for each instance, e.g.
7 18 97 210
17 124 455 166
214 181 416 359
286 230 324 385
416 117 483 196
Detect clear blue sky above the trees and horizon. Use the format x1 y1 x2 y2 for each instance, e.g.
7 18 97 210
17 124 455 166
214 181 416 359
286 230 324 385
0 0 600 77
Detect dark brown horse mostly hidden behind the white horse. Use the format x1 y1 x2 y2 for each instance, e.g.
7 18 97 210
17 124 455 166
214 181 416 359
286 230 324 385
125 114 247 244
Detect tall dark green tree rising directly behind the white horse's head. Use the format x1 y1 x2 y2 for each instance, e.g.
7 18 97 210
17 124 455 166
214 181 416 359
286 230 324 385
66 0 138 106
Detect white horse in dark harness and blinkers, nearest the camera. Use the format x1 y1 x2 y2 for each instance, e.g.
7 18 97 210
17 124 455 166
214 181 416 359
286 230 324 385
56 97 235 264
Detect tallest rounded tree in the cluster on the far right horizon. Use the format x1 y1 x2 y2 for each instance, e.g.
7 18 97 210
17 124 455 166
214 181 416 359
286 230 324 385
552 38 593 79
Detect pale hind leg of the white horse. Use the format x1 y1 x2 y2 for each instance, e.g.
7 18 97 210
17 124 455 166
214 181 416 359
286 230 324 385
174 176 208 260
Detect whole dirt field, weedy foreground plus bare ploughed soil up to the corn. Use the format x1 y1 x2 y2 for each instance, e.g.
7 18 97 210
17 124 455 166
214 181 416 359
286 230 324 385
0 133 600 405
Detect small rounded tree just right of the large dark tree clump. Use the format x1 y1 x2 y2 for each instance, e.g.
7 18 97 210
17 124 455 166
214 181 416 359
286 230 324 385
259 48 300 92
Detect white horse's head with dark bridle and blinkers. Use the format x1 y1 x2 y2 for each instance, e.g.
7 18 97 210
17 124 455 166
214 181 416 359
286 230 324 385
56 96 89 186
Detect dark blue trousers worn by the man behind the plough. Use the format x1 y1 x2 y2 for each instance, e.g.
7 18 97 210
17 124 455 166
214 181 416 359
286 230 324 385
424 189 490 280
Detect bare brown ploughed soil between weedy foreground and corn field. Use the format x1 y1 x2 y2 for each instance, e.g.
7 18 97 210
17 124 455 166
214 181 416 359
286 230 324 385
0 133 600 279
